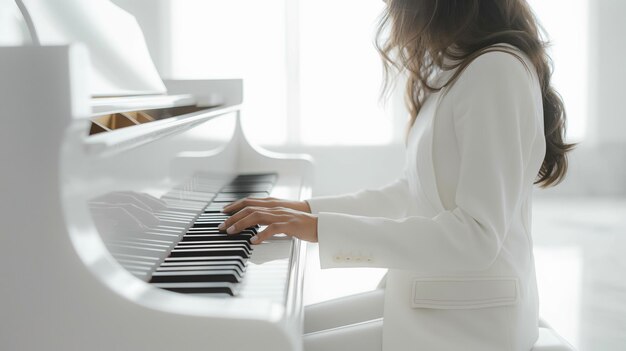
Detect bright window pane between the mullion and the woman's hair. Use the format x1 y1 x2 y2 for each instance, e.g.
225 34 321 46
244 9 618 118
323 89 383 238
300 0 393 144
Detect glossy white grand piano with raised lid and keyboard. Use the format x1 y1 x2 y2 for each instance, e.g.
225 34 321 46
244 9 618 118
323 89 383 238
0 0 313 351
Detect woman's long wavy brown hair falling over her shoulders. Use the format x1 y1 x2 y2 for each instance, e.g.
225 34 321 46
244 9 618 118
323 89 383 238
376 0 574 187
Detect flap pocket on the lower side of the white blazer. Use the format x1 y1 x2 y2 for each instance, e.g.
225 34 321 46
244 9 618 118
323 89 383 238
411 277 519 309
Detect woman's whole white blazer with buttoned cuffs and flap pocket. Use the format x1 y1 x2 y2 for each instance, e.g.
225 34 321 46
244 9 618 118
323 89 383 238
308 47 545 351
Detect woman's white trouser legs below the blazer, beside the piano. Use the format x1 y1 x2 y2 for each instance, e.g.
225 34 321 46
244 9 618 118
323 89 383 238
304 289 385 351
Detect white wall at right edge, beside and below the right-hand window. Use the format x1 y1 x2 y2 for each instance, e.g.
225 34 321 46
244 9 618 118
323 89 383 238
539 0 626 196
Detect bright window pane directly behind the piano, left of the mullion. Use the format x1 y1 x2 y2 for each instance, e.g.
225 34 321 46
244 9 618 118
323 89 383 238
171 0 293 144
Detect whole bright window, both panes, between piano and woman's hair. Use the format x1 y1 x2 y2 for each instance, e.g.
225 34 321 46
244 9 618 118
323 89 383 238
171 0 393 145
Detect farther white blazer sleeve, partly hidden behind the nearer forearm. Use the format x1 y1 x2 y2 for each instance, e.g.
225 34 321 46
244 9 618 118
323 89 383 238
307 177 411 218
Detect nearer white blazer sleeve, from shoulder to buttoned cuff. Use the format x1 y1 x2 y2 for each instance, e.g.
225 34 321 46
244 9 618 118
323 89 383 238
318 52 543 272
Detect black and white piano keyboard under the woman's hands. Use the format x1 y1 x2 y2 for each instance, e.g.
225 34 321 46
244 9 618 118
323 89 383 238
150 174 277 296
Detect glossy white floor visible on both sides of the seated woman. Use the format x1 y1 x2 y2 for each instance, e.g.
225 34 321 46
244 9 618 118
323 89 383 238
304 198 626 351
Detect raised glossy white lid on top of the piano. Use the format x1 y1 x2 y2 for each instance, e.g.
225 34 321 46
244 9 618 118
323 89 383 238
16 0 166 97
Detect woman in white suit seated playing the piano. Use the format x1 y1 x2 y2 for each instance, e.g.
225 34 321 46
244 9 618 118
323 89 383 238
218 0 572 351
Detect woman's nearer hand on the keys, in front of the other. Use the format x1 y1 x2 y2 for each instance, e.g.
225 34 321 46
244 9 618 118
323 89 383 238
218 206 317 244
